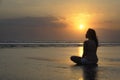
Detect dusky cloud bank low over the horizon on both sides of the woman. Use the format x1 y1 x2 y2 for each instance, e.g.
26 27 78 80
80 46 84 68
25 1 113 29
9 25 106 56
0 16 120 42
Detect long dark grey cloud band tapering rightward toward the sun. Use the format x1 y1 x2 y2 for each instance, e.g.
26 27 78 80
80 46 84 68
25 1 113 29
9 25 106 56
0 16 67 27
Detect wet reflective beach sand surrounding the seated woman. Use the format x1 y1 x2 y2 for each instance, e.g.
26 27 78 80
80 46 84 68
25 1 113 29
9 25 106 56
0 46 120 80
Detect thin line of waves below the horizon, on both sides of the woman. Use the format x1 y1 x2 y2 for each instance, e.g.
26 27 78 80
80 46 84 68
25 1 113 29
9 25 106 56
0 42 120 48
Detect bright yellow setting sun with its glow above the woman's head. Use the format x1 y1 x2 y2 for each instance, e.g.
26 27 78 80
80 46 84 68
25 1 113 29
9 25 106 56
63 13 92 33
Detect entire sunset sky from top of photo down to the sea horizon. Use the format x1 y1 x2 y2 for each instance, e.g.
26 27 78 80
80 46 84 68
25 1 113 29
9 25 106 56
0 0 120 42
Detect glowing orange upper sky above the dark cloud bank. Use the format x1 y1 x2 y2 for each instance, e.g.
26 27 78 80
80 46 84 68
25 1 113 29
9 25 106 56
0 0 120 29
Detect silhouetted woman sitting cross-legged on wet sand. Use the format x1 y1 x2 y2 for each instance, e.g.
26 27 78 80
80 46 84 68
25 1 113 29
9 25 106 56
71 29 98 65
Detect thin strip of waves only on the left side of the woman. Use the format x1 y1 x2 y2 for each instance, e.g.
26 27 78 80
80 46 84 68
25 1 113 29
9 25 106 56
0 42 83 48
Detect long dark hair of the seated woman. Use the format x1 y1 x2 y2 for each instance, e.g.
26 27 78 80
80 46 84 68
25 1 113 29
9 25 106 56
86 28 98 47
